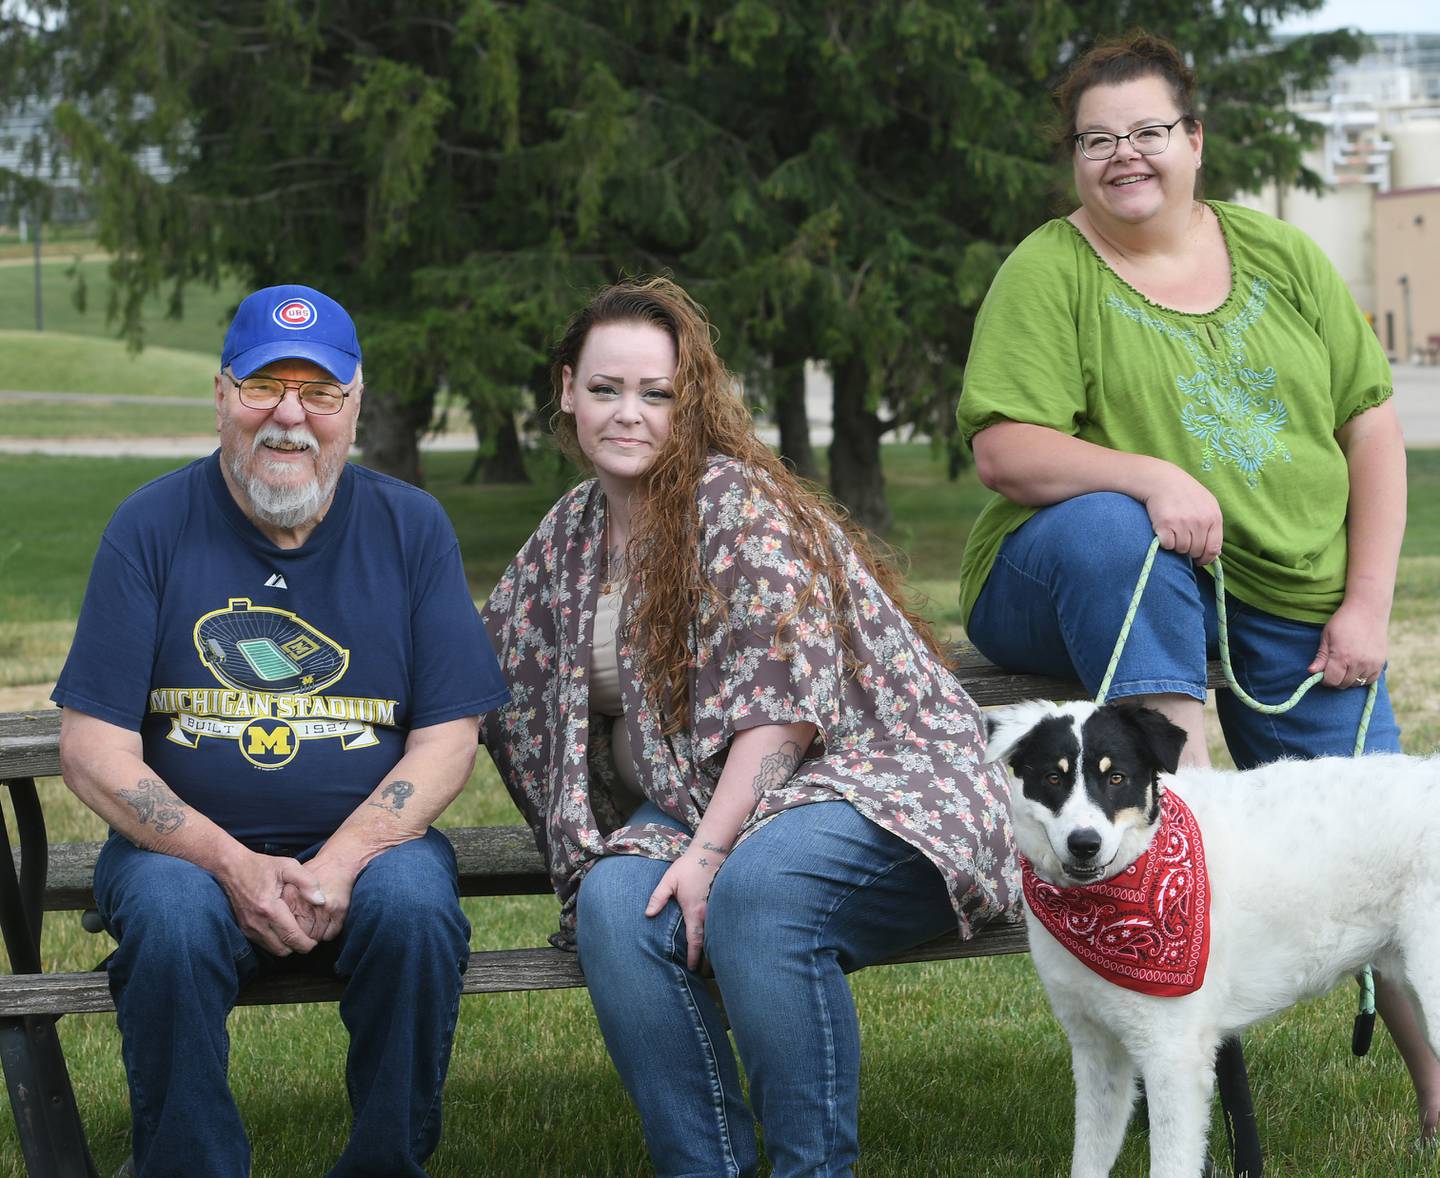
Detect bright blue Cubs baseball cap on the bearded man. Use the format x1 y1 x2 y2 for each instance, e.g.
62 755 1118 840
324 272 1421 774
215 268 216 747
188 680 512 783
220 285 360 385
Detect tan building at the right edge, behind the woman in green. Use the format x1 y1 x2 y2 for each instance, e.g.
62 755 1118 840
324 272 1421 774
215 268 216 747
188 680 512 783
1375 186 1440 364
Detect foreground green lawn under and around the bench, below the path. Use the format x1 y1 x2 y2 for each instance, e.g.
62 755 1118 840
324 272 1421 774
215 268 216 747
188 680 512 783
0 446 1440 1178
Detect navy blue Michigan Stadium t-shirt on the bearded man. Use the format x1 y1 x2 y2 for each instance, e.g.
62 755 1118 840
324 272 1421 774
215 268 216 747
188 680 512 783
50 454 508 845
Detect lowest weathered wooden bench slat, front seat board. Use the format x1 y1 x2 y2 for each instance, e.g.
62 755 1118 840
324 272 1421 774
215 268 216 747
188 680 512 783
0 925 1025 1018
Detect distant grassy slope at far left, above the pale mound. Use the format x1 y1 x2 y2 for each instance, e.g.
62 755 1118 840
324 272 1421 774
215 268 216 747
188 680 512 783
0 254 245 351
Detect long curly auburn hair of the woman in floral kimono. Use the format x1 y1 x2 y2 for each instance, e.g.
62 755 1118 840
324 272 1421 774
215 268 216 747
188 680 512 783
550 278 937 733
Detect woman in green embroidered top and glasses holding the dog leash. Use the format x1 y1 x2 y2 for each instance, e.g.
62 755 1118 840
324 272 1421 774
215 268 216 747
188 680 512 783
959 35 1440 1136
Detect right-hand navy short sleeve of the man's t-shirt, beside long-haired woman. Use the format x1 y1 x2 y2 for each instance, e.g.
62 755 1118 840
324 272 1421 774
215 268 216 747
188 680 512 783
410 524 510 729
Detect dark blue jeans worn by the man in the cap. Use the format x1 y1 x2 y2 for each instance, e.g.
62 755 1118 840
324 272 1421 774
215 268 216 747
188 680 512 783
95 829 469 1178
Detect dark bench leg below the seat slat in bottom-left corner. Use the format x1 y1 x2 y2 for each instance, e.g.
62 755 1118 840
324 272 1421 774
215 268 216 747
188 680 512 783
0 1015 98 1178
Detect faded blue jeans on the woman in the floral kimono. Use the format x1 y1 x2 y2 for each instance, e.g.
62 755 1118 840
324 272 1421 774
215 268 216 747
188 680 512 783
577 802 955 1178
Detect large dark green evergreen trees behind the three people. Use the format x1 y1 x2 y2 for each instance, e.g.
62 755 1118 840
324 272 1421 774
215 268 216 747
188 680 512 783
0 0 1356 530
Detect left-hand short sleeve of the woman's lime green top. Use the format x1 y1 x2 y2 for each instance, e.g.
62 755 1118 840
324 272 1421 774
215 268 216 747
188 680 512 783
956 222 1086 445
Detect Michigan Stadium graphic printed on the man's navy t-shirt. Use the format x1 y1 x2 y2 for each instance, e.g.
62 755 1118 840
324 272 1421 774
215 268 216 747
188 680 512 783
150 598 397 769
